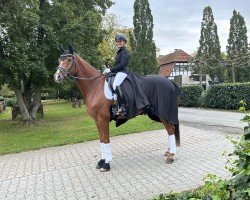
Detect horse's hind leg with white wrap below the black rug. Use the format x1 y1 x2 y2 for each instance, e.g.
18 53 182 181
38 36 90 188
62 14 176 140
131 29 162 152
160 119 180 164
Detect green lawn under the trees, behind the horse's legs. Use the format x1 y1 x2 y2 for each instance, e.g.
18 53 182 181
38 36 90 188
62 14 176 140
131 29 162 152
0 101 163 155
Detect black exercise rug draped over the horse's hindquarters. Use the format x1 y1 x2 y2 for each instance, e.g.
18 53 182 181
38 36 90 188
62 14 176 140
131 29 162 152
112 73 180 127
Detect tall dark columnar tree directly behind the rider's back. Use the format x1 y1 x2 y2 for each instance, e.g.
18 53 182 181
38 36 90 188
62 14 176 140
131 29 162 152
129 0 157 75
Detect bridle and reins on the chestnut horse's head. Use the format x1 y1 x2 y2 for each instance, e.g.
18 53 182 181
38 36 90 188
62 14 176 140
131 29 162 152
57 54 102 80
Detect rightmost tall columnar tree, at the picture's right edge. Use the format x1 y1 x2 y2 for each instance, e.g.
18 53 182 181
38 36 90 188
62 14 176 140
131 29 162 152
227 10 250 82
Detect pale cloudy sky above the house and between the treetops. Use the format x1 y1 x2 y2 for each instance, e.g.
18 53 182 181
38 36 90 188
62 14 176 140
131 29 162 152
108 0 250 55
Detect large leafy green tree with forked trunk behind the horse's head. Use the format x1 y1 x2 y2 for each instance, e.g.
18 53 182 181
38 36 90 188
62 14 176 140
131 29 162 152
0 0 112 121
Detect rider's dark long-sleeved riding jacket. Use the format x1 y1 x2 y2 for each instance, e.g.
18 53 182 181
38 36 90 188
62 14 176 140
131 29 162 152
110 47 129 73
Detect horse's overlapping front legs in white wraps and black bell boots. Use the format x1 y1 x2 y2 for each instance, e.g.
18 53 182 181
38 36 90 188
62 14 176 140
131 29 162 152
96 118 112 172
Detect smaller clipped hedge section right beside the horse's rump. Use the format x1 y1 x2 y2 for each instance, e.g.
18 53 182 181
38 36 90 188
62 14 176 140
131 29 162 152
179 85 203 107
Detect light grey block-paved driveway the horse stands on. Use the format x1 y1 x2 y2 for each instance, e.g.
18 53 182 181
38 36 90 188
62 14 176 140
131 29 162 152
0 125 232 200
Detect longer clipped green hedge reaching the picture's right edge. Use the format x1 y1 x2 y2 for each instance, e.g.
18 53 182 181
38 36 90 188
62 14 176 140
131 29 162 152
203 83 250 109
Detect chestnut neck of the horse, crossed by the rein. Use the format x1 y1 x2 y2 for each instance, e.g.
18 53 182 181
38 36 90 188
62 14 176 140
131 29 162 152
76 56 104 99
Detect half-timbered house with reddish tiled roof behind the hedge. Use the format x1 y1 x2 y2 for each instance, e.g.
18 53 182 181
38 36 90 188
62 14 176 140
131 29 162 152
158 49 194 80
